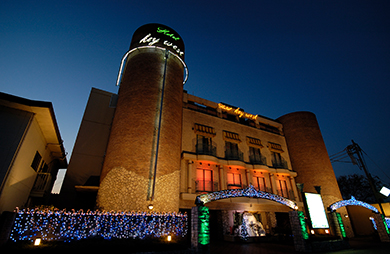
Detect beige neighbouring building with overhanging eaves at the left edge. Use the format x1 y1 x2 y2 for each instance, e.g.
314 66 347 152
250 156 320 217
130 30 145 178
0 93 68 213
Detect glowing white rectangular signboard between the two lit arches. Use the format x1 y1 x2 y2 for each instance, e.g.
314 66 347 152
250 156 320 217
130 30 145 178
305 193 329 228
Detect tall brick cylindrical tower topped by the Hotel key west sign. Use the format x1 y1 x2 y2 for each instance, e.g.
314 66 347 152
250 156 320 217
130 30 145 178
97 24 185 212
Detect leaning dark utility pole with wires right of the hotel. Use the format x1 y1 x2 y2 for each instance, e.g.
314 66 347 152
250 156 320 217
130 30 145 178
347 140 386 216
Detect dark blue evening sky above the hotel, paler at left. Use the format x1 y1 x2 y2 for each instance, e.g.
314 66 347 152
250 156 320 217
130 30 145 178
0 0 390 186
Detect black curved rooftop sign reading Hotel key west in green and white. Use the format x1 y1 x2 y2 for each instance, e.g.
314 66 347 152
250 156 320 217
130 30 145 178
130 24 184 60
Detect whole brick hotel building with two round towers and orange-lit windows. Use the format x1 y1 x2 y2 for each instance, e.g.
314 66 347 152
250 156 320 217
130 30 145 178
61 24 349 238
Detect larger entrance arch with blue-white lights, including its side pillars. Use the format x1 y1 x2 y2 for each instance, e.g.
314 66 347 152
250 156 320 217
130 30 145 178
191 185 305 252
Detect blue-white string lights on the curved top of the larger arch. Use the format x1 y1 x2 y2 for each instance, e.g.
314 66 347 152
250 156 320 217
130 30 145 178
195 184 298 210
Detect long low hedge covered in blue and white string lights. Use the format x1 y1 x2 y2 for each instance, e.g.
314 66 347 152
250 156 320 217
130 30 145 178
10 209 188 242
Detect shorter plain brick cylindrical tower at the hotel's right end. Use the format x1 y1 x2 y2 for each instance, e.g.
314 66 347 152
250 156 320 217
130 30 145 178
278 112 342 207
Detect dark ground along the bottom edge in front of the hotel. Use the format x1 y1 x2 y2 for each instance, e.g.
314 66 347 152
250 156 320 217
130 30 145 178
0 235 390 254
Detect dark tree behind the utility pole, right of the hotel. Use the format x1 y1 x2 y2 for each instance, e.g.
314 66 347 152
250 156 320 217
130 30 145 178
337 174 383 204
